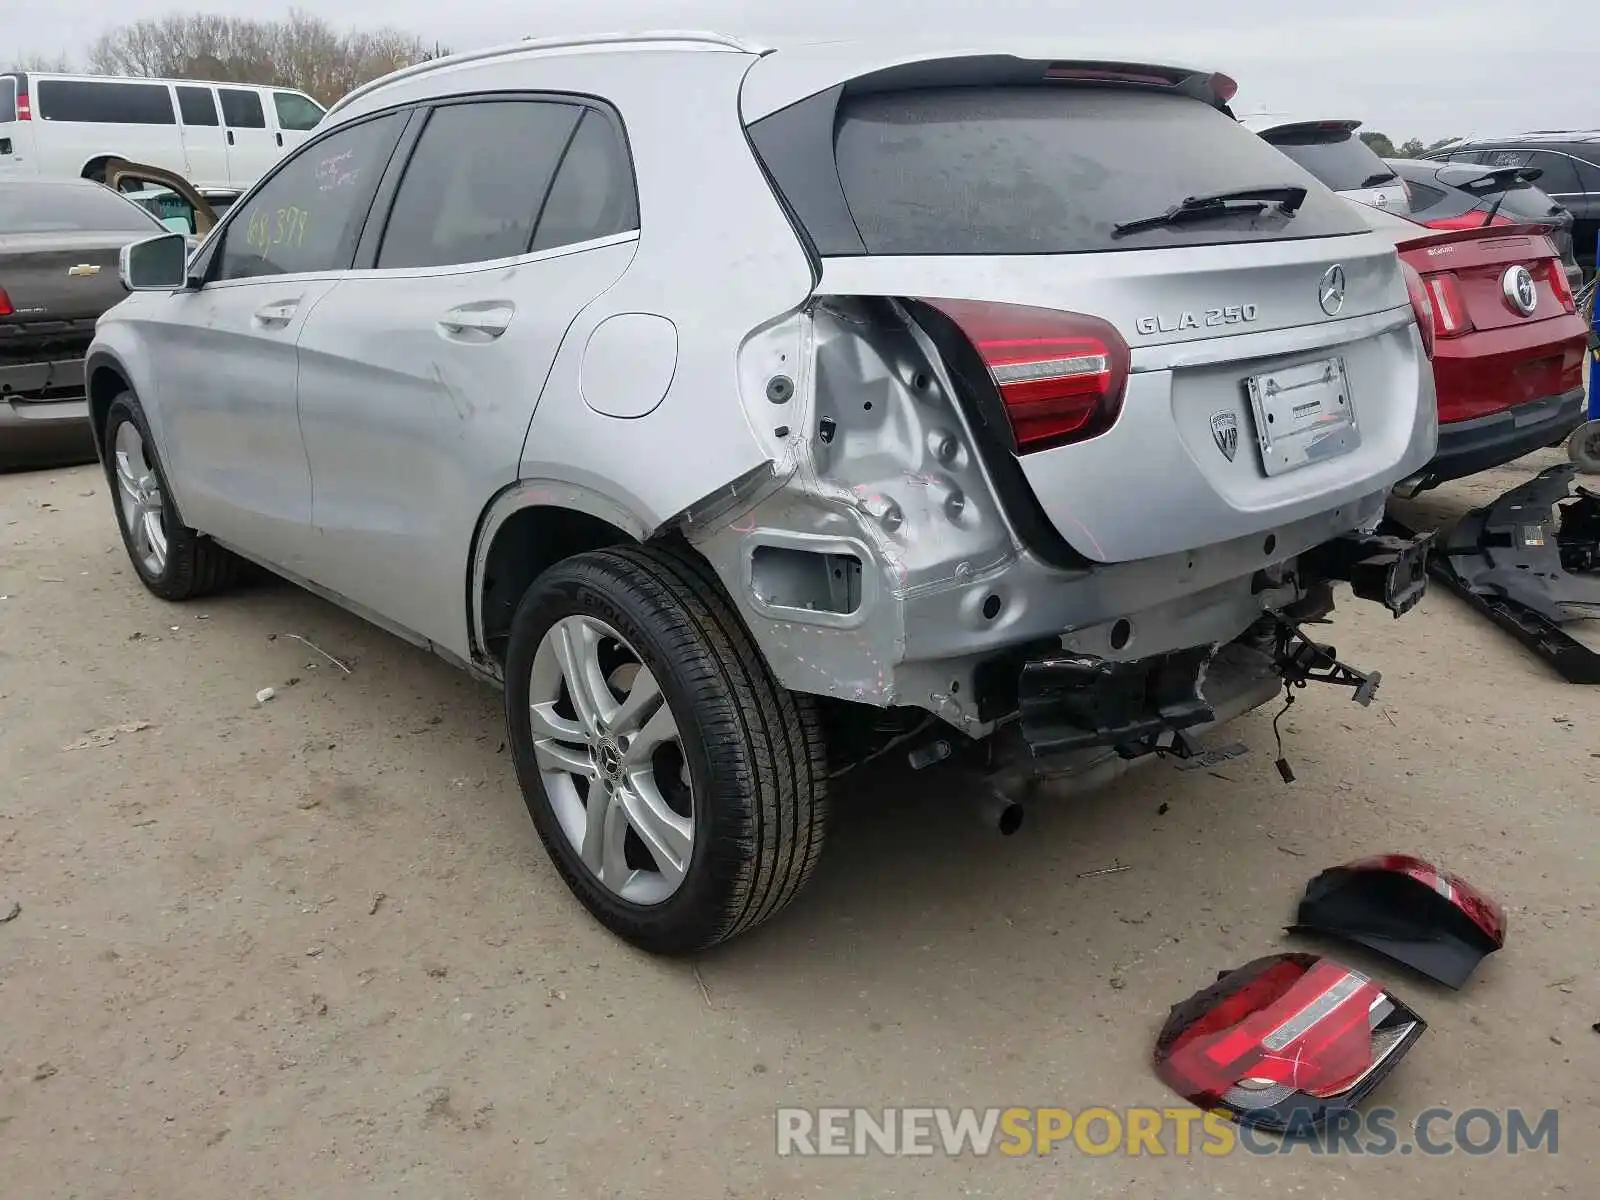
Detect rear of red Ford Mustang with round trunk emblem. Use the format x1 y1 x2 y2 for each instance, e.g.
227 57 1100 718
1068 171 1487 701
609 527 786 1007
1366 210 1589 494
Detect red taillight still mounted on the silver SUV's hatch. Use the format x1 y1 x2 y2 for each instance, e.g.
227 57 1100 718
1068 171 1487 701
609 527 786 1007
925 299 1128 454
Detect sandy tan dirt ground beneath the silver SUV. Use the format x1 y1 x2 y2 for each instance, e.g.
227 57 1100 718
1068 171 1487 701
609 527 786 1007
0 458 1600 1200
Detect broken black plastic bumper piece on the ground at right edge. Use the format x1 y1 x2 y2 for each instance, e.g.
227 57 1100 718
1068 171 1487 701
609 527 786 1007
1397 462 1600 683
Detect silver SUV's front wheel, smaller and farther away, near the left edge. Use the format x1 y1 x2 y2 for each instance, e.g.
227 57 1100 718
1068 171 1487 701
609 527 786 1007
102 392 243 600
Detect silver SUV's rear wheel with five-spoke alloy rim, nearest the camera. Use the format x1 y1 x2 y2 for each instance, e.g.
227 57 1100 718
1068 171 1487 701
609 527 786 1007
506 547 827 954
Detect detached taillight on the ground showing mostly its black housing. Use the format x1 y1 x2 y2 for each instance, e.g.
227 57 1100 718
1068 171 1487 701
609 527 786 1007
1290 854 1506 987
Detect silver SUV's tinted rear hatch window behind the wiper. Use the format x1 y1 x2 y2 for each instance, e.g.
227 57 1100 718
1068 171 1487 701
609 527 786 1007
750 86 1365 254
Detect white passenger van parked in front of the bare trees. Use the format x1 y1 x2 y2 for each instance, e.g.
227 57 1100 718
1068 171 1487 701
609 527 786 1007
0 70 323 194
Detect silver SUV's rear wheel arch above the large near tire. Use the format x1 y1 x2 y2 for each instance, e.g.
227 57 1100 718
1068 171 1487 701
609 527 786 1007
467 480 650 674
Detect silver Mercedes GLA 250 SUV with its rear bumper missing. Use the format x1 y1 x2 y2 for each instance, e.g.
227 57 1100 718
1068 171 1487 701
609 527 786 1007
88 34 1435 954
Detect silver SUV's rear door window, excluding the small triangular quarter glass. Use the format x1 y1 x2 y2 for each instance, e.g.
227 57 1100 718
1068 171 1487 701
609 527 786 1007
376 101 584 269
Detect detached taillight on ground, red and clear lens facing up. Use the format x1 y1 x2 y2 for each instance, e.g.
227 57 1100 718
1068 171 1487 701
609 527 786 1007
1155 954 1427 1133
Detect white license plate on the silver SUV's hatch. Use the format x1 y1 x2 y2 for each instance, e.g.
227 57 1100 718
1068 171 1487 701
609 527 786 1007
1245 357 1360 475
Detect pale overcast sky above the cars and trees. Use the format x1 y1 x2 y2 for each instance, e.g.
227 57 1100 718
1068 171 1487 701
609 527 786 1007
12 0 1600 144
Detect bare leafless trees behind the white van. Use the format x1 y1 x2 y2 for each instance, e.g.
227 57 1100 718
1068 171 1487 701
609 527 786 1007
90 8 442 104
